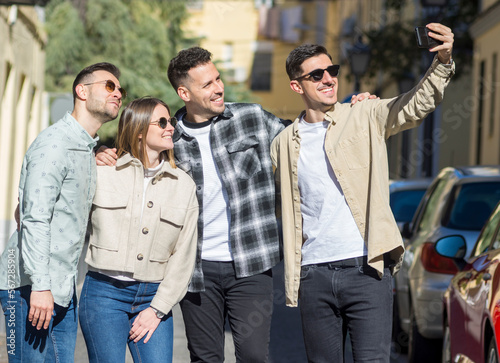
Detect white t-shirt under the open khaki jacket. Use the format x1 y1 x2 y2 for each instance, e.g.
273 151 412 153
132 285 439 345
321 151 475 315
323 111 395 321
298 119 367 265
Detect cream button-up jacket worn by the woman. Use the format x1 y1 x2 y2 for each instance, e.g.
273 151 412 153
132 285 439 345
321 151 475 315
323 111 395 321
85 154 198 314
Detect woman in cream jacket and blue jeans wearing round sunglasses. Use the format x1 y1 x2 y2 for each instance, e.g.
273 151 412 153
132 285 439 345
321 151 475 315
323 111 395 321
79 97 198 362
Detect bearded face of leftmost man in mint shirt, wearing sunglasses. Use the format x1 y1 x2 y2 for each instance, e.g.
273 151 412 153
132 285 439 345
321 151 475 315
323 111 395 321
85 71 122 123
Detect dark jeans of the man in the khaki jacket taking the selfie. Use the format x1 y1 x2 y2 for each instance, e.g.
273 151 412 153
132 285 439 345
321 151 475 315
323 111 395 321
299 258 392 363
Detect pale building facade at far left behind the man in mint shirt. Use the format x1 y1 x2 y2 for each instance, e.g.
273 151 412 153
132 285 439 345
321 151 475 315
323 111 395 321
0 5 48 251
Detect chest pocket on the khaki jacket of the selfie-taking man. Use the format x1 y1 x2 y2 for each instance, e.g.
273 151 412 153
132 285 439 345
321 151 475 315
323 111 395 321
339 129 371 170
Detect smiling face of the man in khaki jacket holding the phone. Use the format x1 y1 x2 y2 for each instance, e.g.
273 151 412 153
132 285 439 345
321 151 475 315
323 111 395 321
290 54 338 112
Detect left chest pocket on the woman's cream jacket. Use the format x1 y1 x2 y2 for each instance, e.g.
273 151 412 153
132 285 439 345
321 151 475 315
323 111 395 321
90 190 130 251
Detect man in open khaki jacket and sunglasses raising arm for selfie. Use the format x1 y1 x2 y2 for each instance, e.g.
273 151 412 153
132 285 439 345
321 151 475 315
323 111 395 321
271 23 454 362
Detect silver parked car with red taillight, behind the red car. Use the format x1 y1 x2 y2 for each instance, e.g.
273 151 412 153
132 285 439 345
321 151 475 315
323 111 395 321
395 166 500 363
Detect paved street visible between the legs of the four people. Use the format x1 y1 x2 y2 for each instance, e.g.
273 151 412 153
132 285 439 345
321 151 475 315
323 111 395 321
0 264 407 363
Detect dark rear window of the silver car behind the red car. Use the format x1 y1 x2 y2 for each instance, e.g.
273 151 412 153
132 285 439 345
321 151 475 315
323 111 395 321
443 182 500 231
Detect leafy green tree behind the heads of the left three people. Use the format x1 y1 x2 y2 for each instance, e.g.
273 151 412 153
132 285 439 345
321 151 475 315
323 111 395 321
46 0 254 144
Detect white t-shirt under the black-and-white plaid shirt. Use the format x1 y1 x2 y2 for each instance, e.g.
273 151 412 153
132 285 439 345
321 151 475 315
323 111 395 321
179 120 233 261
